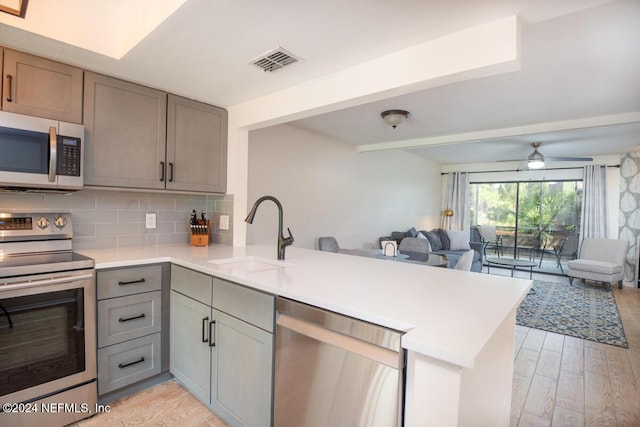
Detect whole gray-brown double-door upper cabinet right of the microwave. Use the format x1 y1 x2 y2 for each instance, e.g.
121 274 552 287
84 72 227 193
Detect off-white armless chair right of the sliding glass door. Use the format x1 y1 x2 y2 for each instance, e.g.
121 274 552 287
567 238 629 289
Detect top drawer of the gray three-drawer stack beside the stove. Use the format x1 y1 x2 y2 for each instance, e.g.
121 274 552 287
97 265 162 300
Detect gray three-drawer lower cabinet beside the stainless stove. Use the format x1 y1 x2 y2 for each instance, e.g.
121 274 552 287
96 264 168 396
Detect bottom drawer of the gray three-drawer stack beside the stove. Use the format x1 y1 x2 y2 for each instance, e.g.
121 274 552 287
98 334 161 395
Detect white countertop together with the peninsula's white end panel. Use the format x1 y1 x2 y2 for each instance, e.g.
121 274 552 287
81 245 531 426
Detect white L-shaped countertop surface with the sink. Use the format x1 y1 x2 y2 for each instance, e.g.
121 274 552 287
78 245 532 368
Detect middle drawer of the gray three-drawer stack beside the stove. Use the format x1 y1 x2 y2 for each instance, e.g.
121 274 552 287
98 291 162 348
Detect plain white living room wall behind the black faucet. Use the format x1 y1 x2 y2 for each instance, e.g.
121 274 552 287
248 125 441 248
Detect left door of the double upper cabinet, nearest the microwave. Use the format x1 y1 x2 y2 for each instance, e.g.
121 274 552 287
84 71 167 189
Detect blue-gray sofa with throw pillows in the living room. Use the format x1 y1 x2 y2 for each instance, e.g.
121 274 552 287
378 227 483 272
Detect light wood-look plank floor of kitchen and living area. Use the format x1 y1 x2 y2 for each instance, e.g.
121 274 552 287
75 269 640 427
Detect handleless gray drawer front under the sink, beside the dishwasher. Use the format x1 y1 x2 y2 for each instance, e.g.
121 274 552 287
213 277 275 332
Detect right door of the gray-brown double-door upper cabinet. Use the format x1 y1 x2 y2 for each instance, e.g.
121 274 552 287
166 95 227 193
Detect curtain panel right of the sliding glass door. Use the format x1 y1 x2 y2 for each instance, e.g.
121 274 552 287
580 165 609 239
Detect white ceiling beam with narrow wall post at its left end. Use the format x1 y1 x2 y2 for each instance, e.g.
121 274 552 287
227 16 521 246
